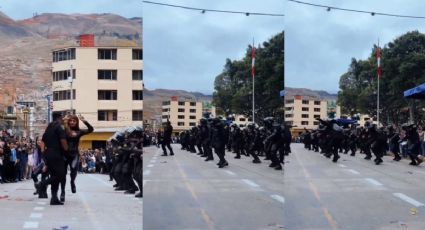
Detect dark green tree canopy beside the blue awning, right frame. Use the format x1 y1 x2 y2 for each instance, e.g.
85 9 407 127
338 31 425 125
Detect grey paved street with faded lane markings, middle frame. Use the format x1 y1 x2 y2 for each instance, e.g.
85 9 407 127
144 145 284 230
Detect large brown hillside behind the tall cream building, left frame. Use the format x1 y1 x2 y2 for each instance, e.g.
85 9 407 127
0 12 142 134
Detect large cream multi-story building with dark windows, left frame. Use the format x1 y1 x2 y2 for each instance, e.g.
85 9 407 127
52 35 143 149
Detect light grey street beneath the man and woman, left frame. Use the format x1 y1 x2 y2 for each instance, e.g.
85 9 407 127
0 174 143 230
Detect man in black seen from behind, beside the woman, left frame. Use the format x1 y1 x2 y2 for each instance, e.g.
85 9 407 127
36 113 68 205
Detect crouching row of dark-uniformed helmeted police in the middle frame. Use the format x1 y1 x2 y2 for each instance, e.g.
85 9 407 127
174 117 291 170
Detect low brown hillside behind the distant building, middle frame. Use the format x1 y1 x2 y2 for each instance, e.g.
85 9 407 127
143 88 212 120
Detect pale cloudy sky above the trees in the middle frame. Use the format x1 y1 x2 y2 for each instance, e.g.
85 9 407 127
143 0 285 94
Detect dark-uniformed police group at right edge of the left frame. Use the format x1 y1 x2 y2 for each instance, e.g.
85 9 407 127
107 127 143 197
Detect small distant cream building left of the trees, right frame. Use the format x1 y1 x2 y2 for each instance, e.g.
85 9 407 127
285 95 341 135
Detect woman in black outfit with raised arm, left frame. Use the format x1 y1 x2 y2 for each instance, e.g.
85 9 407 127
60 115 94 202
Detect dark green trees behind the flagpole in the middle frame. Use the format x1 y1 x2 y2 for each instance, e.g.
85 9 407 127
213 32 284 120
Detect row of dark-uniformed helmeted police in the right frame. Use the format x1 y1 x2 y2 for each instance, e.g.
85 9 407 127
302 119 422 165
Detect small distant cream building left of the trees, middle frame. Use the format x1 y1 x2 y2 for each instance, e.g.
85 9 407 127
162 97 203 133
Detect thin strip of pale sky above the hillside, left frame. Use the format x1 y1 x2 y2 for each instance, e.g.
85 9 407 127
0 0 142 20
